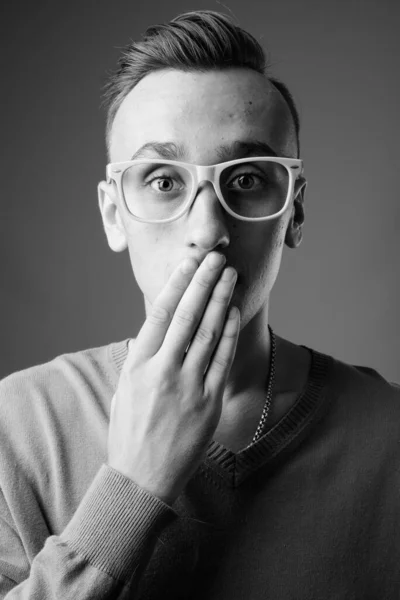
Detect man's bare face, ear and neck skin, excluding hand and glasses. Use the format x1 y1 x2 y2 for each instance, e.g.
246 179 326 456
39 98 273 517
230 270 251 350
99 69 308 450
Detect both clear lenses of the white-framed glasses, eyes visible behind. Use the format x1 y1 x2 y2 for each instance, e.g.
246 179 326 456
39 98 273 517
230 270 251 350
122 160 289 221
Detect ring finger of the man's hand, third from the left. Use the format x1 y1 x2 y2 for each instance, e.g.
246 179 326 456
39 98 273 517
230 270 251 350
183 267 237 376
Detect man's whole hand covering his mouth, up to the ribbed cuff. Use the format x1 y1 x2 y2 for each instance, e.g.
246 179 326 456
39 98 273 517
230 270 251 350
108 252 240 505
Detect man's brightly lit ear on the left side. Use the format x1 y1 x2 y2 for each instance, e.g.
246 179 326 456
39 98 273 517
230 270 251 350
97 181 128 252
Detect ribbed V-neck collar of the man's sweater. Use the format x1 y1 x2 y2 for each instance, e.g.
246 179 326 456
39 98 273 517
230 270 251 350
110 340 332 487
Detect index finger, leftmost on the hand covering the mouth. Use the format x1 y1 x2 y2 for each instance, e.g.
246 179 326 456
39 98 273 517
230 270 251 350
131 252 224 358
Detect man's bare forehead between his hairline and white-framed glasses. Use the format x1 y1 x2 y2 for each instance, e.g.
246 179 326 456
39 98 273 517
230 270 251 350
110 69 296 164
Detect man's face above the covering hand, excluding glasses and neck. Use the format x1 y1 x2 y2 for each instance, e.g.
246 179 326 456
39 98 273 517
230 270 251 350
100 69 301 327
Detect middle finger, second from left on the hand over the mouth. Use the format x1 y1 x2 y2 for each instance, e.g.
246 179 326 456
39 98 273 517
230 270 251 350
162 252 228 364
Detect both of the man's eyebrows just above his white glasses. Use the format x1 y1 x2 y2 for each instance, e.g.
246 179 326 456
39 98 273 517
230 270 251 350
130 140 278 162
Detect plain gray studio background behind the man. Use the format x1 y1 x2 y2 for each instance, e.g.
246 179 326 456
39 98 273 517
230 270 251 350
0 0 400 381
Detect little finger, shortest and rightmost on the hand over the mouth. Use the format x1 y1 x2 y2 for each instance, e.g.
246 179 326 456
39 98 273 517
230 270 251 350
204 306 240 397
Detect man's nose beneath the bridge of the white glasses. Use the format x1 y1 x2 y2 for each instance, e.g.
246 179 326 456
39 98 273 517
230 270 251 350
185 181 230 252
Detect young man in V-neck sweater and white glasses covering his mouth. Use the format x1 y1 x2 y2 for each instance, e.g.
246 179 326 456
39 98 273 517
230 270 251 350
0 11 400 600
